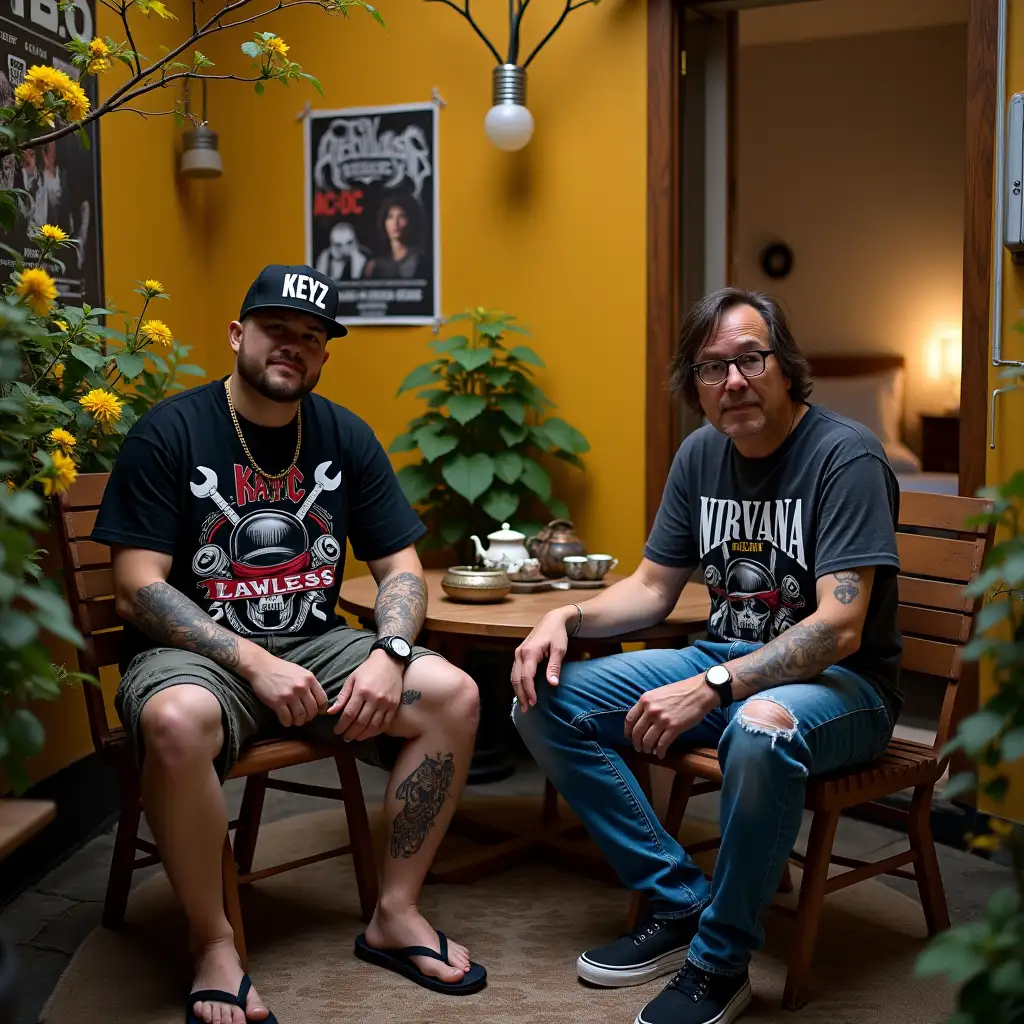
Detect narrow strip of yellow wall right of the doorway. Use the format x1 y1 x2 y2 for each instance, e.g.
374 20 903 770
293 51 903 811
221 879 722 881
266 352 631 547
982 0 1024 821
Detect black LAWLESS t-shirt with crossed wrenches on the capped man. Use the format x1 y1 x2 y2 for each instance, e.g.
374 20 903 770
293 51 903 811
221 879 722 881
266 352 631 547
92 380 426 667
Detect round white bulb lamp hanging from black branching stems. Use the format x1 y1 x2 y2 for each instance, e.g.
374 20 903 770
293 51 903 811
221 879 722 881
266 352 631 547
427 0 600 151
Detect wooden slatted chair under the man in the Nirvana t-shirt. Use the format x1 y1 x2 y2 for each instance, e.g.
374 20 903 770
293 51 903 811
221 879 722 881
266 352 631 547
629 492 993 1010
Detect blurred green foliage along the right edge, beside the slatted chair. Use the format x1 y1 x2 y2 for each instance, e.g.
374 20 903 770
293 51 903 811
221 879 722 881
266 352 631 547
918 436 1024 1024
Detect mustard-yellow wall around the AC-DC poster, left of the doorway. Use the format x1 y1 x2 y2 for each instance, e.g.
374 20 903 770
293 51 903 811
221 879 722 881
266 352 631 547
16 0 646 777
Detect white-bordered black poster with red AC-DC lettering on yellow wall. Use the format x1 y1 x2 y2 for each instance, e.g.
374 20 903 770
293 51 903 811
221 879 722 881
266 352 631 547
305 102 440 326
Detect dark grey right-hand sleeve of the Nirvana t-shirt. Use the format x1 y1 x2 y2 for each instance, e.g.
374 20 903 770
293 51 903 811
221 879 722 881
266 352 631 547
814 453 899 579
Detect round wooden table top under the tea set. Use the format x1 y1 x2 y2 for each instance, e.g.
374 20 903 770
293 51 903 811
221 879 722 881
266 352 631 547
339 569 711 642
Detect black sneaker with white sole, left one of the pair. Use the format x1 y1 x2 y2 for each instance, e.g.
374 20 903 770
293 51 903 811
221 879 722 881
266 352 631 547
577 913 700 988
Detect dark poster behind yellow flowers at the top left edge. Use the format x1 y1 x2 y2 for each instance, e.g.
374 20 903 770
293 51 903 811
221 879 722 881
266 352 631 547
0 0 103 306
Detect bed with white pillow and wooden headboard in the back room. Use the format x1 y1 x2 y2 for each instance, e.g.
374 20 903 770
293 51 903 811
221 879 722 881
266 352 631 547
808 353 958 495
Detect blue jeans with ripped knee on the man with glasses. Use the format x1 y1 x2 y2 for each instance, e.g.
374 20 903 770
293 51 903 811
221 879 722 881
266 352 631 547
512 641 892 974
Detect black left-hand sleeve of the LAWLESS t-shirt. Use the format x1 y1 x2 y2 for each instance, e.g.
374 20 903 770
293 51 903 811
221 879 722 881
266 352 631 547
92 435 181 555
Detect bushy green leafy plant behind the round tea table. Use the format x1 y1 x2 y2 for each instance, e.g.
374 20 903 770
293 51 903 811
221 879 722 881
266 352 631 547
388 307 590 561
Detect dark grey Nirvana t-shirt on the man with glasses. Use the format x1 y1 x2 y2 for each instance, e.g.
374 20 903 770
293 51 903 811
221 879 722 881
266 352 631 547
644 406 902 721
